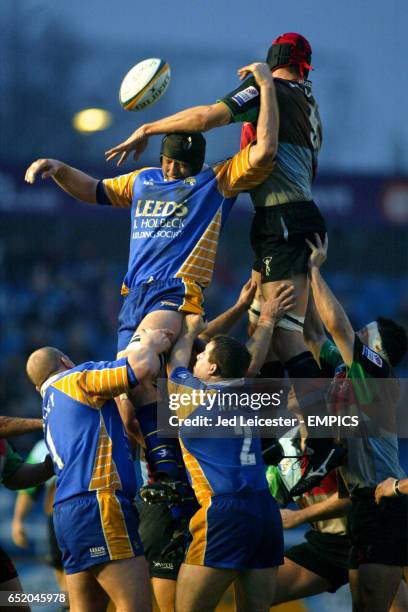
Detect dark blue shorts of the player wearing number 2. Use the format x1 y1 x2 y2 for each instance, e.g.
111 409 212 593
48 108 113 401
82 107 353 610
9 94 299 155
185 490 283 570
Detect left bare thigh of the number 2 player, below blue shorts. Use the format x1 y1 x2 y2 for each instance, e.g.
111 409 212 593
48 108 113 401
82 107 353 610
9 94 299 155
176 563 238 612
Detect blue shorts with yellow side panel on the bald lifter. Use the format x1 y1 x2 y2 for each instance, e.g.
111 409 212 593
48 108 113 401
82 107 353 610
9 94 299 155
54 491 143 574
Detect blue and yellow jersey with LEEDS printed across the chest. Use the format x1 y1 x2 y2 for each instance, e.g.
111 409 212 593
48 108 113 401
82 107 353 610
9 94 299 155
97 145 273 295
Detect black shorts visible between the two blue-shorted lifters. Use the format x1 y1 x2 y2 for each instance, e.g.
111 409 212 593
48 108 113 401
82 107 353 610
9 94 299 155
136 501 185 580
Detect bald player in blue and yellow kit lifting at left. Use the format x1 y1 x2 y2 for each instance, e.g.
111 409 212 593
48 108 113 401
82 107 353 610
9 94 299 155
27 330 170 612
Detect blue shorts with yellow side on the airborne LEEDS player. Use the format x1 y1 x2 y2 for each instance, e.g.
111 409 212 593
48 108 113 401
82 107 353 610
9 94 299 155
118 278 204 353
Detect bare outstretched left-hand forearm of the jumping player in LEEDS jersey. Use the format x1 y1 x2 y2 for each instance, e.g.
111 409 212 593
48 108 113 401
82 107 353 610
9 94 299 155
24 159 99 204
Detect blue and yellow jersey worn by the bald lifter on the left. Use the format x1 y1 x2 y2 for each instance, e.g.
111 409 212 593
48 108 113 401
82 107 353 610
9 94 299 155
41 358 137 504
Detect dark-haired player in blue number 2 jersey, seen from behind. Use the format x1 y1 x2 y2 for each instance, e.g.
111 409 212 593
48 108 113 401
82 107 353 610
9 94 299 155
168 311 284 612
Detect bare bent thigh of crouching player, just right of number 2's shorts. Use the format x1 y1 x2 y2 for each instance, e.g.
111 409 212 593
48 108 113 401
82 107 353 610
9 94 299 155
272 557 330 606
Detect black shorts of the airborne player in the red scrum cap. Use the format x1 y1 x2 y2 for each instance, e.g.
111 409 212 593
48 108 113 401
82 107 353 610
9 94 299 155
251 201 326 283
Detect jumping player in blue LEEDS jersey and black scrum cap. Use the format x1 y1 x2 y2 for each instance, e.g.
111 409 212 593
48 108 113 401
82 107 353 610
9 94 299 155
25 63 279 351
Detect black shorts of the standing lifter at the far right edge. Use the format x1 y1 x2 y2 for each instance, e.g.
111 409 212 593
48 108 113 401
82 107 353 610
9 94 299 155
348 489 408 569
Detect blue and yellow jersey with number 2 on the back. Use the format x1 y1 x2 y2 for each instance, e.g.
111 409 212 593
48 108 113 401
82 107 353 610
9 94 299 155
168 367 268 506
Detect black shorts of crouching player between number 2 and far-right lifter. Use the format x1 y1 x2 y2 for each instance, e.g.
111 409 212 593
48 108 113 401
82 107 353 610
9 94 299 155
285 529 350 593
